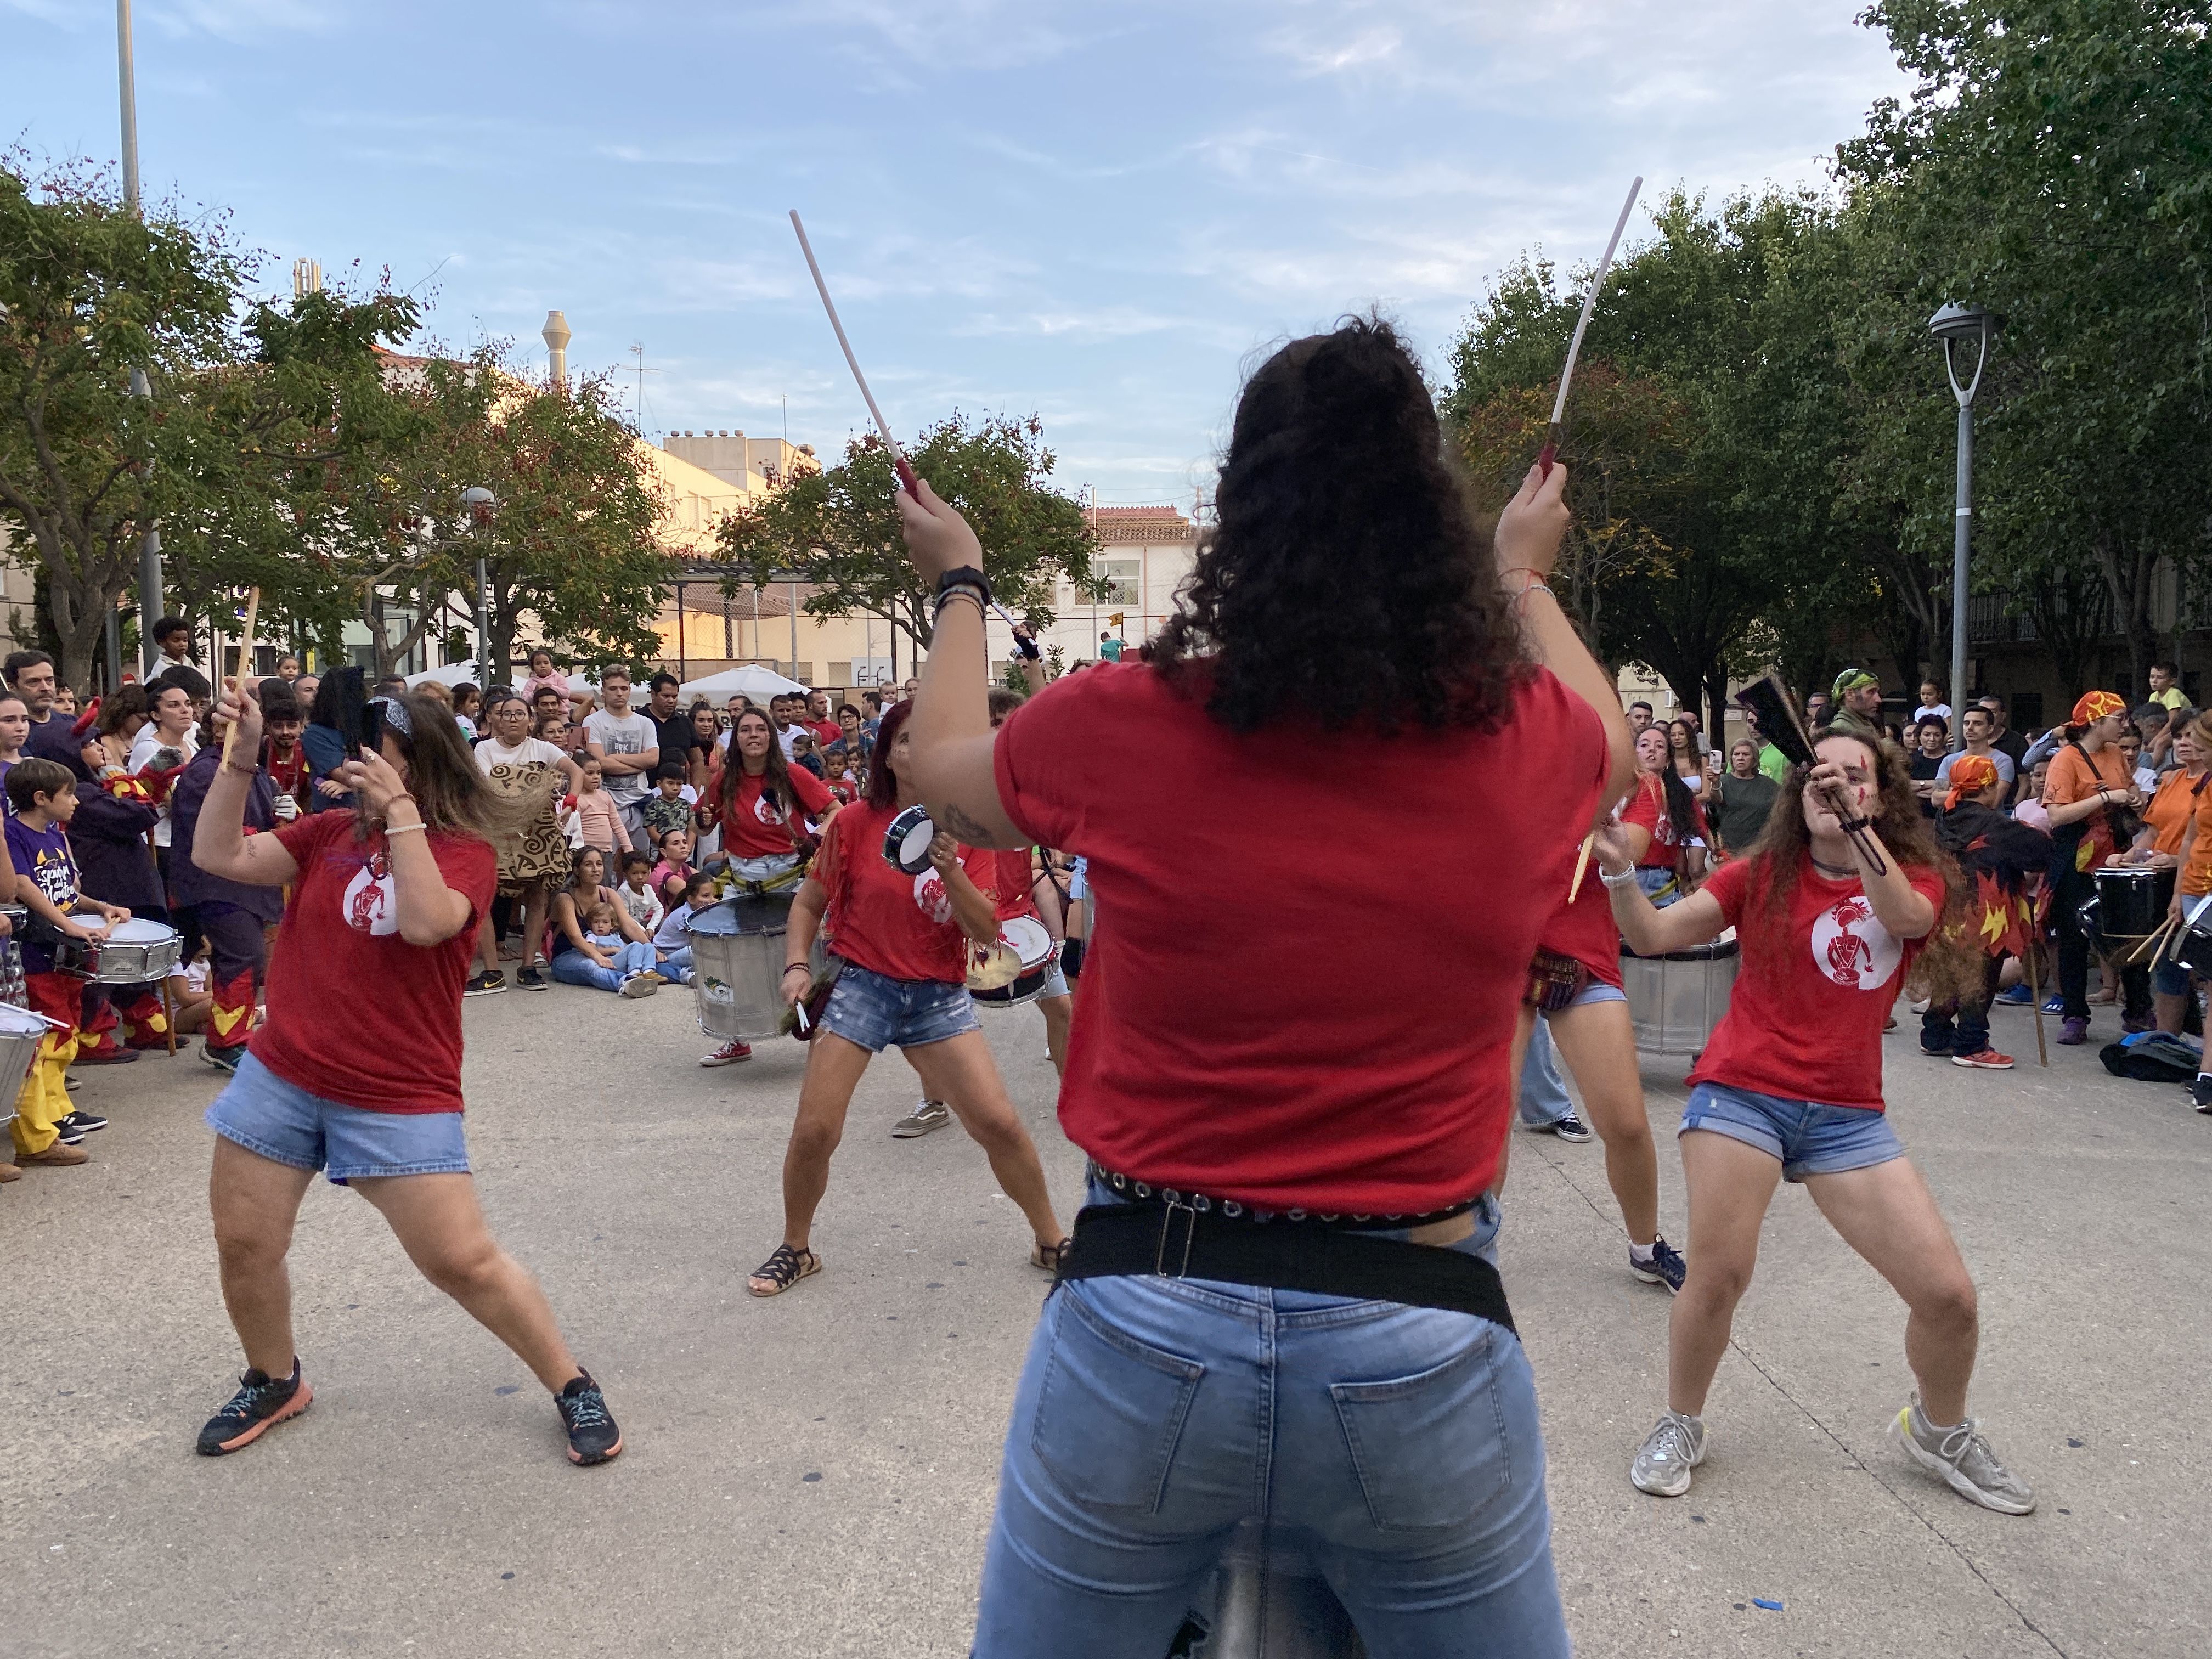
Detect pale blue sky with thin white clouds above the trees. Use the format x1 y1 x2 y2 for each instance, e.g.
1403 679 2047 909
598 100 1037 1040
0 0 1905 506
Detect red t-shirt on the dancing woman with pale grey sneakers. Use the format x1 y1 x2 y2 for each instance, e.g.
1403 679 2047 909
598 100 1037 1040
1690 854 1944 1113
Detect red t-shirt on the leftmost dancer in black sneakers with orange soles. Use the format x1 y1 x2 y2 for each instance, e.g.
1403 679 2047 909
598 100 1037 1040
252 812 500 1113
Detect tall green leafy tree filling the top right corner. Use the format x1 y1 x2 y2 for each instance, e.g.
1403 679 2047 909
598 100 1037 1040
1838 0 2212 684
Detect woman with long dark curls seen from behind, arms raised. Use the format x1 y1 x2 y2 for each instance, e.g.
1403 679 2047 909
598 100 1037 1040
900 321 1628 1659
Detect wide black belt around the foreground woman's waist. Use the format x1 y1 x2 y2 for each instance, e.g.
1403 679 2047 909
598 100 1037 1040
1053 1199 1517 1334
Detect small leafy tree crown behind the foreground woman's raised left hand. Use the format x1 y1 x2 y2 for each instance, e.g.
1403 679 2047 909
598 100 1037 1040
716 414 1104 650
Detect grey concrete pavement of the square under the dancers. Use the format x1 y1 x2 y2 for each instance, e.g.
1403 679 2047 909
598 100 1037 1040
0 986 2212 1659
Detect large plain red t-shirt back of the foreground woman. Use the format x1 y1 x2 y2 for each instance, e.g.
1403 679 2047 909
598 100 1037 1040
995 662 1608 1215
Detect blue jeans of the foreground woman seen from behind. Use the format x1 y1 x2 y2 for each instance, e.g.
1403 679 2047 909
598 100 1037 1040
973 1186 1568 1659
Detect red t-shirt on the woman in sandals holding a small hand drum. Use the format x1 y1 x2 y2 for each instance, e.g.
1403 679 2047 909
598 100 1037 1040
814 801 991 984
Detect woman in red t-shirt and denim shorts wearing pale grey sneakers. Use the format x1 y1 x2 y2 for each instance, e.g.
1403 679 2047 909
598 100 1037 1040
1597 728 2035 1515
